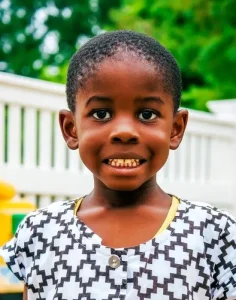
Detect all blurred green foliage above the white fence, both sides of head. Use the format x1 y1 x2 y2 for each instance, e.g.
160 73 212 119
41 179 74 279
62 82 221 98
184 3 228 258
0 0 236 110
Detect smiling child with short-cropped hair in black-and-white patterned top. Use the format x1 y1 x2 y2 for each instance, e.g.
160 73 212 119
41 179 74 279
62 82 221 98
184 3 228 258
2 31 236 300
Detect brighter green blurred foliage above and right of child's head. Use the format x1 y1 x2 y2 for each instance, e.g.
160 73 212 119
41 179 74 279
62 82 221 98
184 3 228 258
107 0 236 110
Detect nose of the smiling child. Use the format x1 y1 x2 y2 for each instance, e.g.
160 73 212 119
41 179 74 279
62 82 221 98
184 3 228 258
110 121 139 144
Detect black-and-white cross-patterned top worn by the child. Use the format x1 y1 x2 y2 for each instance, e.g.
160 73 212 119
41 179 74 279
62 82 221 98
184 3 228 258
0 200 236 300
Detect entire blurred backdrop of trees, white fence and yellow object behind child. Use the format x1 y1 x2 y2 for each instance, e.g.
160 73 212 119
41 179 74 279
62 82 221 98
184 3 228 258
0 0 236 300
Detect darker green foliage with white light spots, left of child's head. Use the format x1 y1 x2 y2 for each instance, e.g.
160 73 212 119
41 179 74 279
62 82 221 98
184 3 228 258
0 0 120 82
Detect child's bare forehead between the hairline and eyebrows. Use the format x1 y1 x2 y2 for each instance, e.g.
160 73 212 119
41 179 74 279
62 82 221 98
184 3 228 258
77 56 173 105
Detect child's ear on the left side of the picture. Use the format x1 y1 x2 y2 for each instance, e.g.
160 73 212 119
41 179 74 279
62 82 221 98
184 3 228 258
59 109 79 150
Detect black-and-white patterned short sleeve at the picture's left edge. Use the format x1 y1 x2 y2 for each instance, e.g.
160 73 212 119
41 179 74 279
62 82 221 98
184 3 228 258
0 217 29 282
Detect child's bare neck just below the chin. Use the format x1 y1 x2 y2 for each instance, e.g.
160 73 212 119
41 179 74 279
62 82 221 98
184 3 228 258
86 178 170 209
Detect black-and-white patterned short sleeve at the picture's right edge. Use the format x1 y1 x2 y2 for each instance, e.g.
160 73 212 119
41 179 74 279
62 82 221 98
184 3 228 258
212 217 236 300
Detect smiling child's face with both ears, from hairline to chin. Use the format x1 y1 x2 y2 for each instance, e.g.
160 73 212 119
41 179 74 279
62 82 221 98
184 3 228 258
60 58 187 191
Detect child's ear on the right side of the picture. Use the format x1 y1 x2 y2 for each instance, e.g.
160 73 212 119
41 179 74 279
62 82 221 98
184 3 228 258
170 109 188 150
